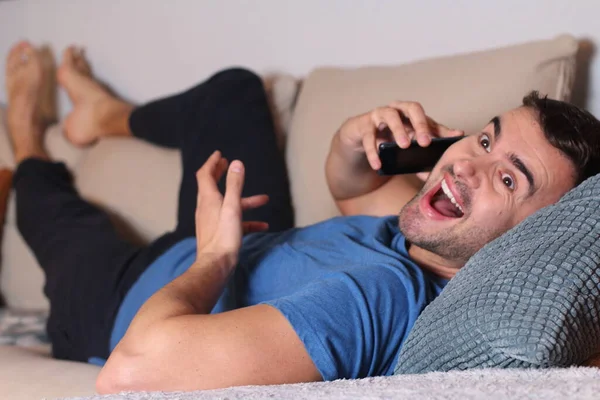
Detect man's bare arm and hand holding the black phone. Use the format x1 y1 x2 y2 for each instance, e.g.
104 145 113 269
325 101 464 216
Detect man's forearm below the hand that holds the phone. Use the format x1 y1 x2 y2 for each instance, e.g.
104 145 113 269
325 132 390 201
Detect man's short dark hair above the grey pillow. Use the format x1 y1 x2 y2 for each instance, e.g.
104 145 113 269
523 91 600 185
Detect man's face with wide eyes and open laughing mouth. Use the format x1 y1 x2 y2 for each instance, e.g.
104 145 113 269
400 107 575 267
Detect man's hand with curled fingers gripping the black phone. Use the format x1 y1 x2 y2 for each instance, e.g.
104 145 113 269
339 101 464 177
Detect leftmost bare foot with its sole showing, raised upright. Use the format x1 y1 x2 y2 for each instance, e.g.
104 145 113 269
6 42 48 164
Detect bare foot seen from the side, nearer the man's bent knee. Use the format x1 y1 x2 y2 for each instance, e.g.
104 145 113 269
57 46 133 146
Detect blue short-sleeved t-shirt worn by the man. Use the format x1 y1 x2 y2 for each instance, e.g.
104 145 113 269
105 216 447 380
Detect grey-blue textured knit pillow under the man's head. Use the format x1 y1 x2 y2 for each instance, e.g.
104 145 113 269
394 175 600 374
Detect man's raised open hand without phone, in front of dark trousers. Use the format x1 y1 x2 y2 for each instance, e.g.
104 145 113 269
196 151 269 268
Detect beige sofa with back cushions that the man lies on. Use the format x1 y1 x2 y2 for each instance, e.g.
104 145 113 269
0 36 578 399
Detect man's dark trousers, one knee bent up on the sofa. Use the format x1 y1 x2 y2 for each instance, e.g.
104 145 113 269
13 69 294 361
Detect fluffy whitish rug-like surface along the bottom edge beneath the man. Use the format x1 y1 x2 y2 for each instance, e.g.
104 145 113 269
62 367 600 400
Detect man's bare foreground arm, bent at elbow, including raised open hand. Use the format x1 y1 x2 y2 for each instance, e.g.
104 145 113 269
96 152 322 393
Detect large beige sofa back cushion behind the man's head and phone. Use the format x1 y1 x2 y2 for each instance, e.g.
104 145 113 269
286 36 578 226
